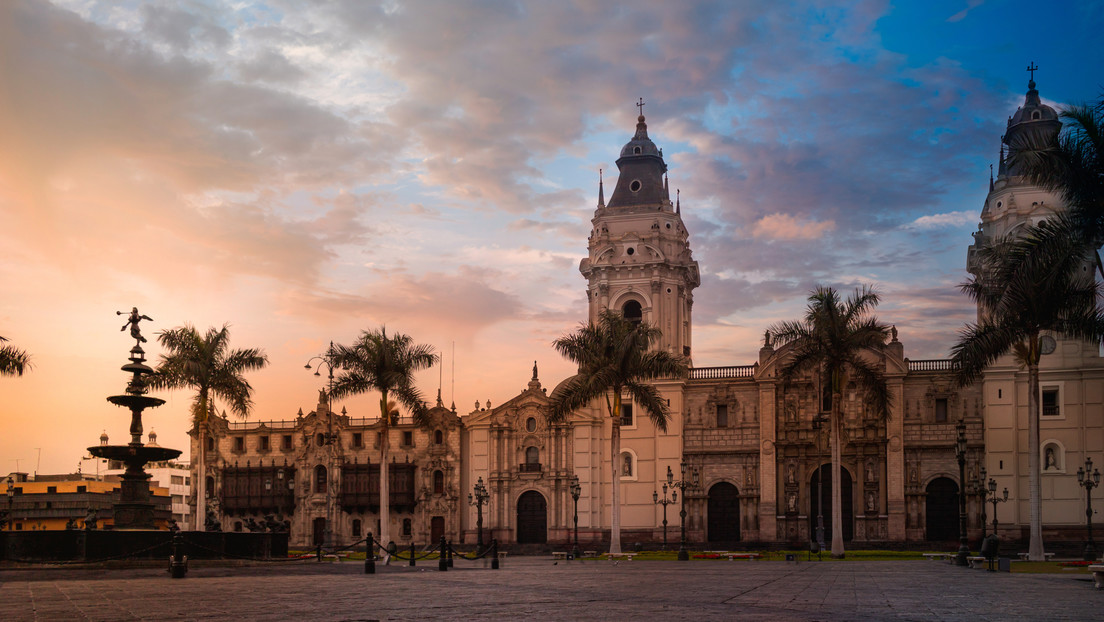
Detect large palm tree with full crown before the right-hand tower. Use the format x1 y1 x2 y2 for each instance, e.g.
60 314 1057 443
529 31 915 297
952 220 1104 561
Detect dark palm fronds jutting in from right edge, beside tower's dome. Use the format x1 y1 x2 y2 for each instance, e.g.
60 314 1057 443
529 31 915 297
1008 96 1104 276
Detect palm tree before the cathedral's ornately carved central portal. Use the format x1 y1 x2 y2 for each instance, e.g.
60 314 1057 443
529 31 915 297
768 285 890 558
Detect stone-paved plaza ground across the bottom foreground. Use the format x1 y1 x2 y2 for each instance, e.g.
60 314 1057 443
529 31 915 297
0 557 1104 622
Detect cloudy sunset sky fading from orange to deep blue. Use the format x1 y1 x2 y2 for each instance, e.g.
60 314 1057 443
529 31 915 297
0 0 1104 473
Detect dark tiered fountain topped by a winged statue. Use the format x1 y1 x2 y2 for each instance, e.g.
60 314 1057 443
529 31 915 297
88 307 181 529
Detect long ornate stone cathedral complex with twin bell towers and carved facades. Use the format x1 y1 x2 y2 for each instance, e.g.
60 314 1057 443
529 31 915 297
192 80 1104 549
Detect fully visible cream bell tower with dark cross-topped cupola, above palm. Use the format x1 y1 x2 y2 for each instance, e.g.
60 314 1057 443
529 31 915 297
578 99 701 358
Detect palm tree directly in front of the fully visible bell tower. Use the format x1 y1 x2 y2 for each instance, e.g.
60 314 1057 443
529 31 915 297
549 309 689 555
